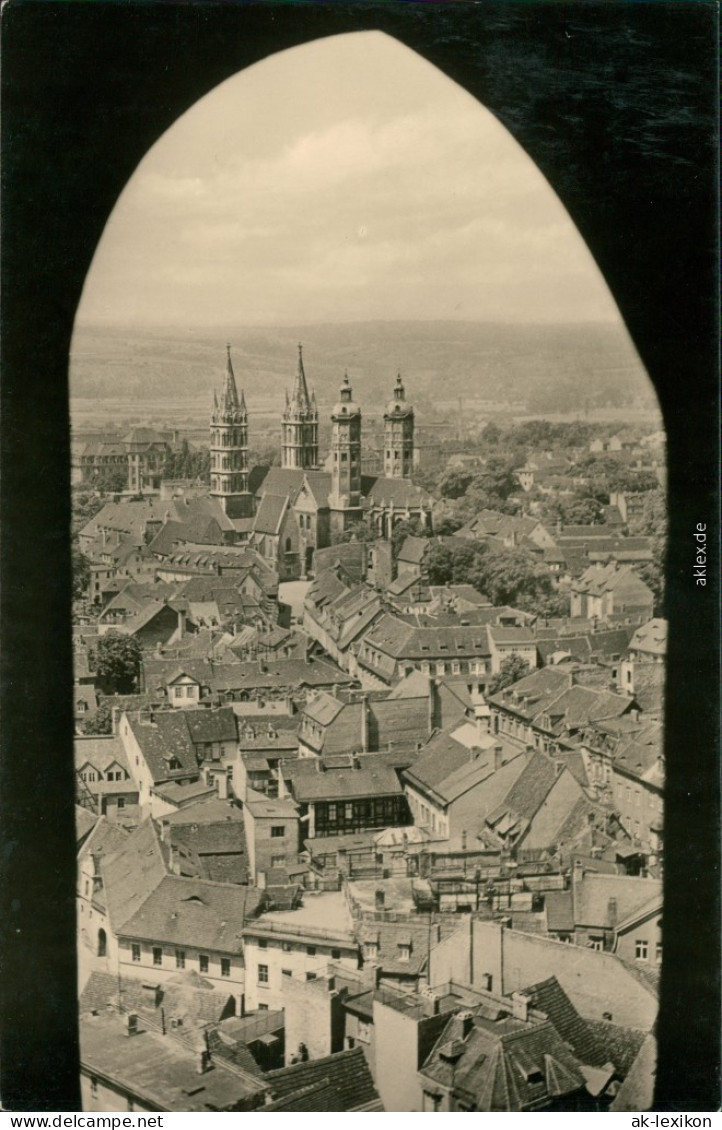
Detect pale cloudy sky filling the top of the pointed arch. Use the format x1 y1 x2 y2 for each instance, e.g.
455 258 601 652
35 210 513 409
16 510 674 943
78 32 618 327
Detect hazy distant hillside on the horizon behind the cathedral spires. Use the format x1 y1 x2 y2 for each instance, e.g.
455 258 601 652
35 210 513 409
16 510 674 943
70 322 654 412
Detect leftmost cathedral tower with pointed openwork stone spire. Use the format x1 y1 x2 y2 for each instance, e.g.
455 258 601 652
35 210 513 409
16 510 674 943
210 346 253 518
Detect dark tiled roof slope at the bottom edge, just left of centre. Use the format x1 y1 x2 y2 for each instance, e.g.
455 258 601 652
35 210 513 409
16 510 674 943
261 1048 383 1113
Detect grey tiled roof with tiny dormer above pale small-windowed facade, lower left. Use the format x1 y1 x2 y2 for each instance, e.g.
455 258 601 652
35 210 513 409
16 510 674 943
119 875 266 954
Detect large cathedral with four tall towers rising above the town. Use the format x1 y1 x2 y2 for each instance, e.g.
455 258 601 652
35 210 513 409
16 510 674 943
210 346 432 581
